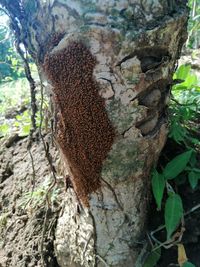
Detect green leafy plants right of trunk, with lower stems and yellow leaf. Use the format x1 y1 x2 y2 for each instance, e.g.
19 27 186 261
144 65 200 267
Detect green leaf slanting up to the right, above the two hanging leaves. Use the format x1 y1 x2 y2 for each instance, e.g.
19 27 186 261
163 150 192 180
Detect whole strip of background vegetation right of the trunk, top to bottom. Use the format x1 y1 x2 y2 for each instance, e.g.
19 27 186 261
145 0 200 267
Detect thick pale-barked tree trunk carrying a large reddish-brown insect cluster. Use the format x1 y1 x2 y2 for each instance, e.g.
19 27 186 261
0 0 187 267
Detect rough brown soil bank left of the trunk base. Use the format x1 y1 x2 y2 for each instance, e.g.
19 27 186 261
0 137 64 267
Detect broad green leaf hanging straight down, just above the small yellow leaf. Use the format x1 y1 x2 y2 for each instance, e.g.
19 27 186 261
165 194 183 239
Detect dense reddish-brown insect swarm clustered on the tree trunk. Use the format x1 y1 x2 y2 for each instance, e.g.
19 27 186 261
44 42 115 205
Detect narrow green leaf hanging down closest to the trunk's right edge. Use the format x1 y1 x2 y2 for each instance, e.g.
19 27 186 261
151 170 165 210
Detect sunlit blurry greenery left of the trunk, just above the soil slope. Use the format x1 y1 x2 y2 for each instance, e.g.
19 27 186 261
0 74 48 137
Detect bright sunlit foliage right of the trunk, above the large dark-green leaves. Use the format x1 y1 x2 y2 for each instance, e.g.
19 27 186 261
169 65 200 147
